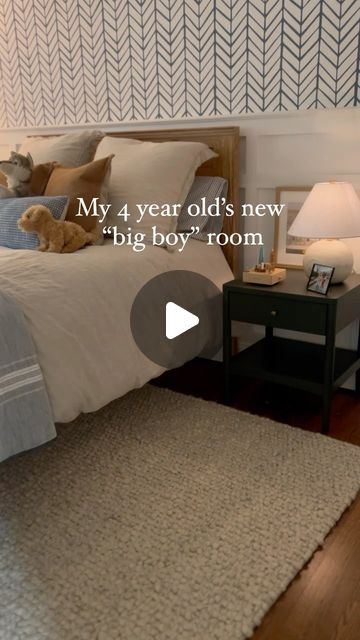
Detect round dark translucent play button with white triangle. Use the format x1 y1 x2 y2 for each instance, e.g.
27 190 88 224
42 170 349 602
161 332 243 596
130 269 222 369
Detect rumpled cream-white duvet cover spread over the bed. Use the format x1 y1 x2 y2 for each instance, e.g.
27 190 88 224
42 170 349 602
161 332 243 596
0 240 232 422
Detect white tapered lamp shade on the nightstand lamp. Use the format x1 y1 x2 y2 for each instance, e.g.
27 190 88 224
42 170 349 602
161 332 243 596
288 182 360 238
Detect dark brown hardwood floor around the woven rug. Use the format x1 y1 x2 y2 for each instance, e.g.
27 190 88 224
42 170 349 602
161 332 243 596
154 359 360 640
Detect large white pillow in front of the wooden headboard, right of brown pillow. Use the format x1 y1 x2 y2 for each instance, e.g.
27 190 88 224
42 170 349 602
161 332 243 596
95 136 217 239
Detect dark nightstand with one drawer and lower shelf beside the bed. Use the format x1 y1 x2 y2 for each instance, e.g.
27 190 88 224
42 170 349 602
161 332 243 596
223 270 360 433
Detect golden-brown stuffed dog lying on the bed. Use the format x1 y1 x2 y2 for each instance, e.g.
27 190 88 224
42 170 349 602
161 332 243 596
17 204 99 253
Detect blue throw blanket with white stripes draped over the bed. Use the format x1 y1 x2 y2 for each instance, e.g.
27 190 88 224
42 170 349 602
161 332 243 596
0 293 56 461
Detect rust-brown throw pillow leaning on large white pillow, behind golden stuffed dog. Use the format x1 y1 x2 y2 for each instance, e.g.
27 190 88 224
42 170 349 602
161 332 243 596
44 155 113 231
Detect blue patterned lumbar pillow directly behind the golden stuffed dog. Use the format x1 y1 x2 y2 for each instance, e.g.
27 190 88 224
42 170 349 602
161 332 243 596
0 196 69 249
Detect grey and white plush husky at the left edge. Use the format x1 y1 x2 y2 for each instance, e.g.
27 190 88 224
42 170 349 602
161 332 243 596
0 151 34 198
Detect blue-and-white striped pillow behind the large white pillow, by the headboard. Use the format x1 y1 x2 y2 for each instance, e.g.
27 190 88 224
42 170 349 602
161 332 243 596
176 176 228 242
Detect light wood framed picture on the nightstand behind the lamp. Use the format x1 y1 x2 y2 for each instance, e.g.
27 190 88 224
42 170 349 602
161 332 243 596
274 187 314 269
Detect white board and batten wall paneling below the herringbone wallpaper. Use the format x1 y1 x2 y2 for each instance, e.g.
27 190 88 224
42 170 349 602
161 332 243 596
0 107 360 384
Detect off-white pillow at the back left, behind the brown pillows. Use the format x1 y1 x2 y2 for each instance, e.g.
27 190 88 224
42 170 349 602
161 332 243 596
19 131 104 167
